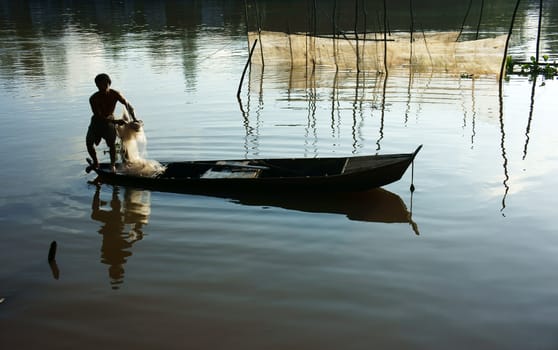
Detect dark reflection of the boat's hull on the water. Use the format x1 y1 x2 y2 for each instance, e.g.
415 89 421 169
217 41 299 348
220 188 419 235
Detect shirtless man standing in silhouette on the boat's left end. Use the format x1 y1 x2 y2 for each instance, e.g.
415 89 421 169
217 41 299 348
85 73 138 172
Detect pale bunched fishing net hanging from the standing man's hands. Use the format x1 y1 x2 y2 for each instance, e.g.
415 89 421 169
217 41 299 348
116 113 165 176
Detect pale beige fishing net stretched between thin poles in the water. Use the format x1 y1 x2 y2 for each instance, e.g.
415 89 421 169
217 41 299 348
249 31 506 74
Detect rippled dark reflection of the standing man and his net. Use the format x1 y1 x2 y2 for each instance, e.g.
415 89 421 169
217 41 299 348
91 186 149 289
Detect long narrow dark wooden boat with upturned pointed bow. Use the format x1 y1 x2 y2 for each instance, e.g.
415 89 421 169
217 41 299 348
86 145 422 193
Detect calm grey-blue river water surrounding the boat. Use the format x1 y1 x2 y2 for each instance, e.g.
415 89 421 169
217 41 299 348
0 0 558 349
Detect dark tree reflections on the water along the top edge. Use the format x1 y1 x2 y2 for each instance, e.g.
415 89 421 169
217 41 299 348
0 0 558 86
